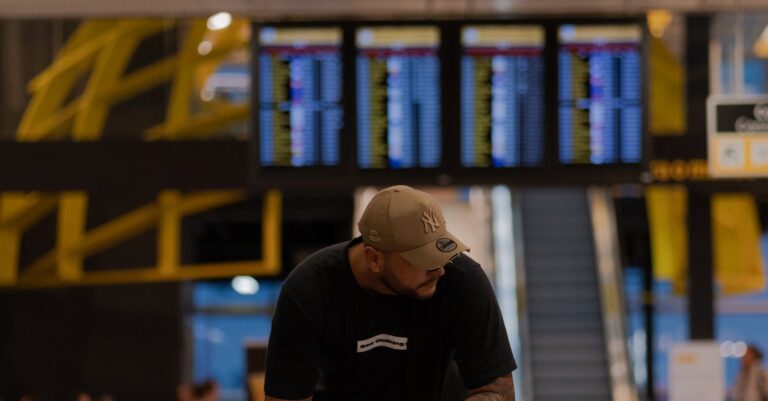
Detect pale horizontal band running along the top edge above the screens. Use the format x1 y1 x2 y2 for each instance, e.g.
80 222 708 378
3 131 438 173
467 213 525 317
0 0 768 19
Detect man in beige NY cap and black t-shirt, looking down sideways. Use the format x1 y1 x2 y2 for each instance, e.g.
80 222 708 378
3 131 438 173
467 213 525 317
265 185 516 401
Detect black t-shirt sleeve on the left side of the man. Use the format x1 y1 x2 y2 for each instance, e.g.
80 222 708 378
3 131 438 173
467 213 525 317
264 290 321 400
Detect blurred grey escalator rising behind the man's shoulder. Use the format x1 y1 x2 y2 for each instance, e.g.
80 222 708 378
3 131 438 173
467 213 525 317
512 188 637 401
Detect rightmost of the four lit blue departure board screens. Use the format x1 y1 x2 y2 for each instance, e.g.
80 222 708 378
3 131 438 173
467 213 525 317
558 25 643 164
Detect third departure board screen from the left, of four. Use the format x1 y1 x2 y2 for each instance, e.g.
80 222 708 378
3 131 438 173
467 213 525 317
461 25 544 167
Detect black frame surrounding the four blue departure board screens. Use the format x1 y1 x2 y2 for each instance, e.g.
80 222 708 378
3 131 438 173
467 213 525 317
249 15 651 189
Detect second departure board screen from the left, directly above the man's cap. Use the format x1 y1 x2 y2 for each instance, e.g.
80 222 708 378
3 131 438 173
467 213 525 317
355 26 441 169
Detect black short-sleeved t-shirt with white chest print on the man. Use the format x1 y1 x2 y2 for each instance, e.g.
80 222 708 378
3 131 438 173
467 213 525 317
265 238 517 401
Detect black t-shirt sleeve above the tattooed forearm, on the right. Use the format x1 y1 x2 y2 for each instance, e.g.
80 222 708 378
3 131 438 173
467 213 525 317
454 264 517 389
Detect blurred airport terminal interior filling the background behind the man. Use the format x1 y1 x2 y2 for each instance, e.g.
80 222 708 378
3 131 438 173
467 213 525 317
0 0 768 401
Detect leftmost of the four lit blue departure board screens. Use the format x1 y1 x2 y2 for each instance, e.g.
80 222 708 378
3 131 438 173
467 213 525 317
258 27 343 167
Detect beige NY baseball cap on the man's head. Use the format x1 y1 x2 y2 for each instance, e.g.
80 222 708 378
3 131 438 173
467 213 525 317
357 185 469 270
